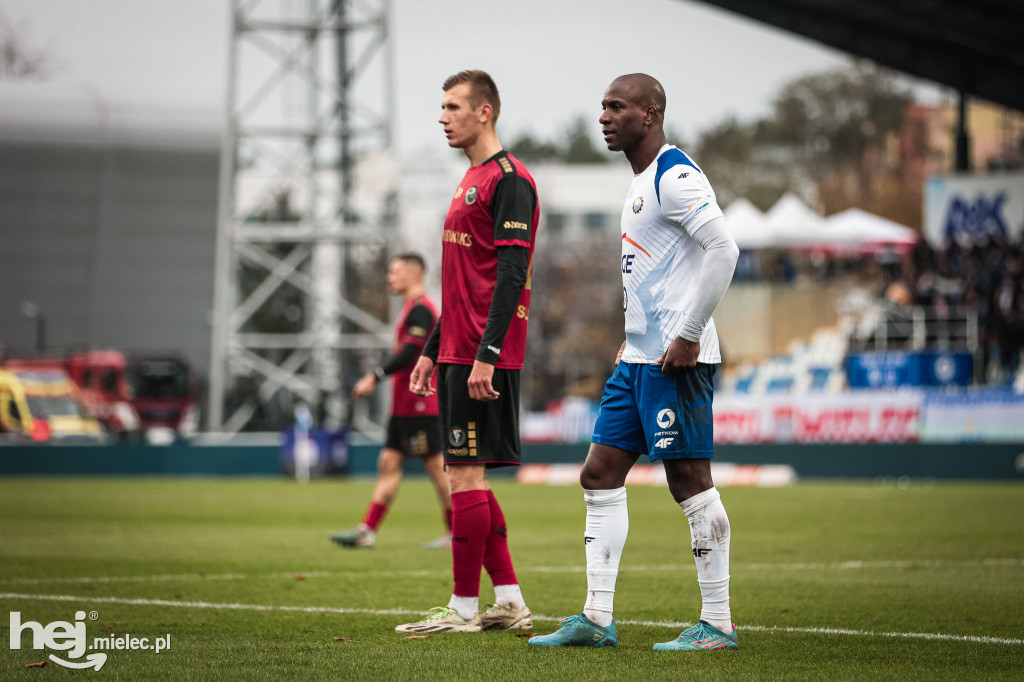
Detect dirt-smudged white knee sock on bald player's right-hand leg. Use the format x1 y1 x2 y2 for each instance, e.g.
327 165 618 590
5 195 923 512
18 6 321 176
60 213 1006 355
679 487 732 634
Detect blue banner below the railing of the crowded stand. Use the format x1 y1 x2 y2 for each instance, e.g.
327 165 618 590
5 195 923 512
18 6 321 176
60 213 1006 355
846 351 974 388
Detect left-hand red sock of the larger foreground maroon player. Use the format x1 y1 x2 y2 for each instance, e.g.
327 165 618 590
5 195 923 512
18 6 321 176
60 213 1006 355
452 491 490 597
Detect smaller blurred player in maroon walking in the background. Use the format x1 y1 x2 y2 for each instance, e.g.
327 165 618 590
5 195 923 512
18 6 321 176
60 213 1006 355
330 253 452 548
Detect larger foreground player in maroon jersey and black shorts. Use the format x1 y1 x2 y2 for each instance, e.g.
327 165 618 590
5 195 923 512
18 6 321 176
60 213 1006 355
396 71 540 633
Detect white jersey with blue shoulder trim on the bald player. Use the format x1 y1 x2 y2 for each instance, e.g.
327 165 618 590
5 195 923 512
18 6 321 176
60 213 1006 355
622 144 722 365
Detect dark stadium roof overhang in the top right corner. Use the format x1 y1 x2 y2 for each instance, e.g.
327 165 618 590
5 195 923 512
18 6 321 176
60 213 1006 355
688 0 1024 111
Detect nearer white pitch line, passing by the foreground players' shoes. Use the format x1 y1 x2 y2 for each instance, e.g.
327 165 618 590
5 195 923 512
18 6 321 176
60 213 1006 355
0 592 1024 645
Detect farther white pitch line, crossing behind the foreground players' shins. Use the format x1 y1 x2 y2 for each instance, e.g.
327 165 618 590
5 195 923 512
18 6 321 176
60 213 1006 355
0 559 1024 585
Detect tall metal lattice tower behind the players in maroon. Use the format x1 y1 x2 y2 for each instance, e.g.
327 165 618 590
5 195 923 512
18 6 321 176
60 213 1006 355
209 0 397 433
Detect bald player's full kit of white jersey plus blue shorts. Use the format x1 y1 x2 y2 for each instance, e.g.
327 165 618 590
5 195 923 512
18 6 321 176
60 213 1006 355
593 144 722 461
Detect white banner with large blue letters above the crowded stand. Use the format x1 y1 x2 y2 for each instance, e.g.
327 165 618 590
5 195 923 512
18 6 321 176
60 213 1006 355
924 172 1024 247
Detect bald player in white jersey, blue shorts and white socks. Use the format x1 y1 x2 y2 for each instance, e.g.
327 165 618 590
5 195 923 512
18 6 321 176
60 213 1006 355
529 74 739 651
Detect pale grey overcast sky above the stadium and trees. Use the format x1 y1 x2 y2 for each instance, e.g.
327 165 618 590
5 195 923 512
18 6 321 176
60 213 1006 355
0 0 942 153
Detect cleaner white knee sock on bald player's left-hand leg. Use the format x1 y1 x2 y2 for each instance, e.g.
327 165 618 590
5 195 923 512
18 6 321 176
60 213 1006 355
583 486 630 628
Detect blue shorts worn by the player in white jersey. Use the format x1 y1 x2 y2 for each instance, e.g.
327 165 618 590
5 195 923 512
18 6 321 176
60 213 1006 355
592 363 718 461
